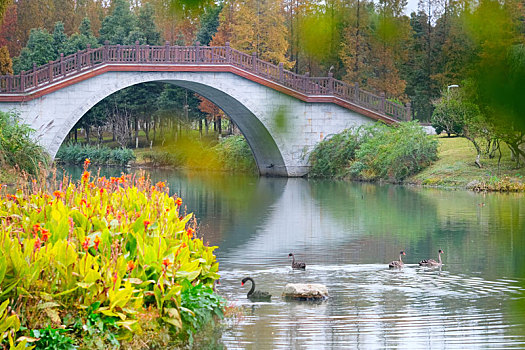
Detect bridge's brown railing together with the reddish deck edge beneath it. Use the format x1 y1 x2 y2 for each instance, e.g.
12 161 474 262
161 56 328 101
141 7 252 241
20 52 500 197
0 43 411 123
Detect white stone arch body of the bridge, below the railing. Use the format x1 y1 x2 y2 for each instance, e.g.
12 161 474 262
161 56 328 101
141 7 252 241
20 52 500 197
0 68 374 177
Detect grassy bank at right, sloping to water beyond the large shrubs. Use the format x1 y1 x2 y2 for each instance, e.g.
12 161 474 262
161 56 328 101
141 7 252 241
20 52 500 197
404 136 525 190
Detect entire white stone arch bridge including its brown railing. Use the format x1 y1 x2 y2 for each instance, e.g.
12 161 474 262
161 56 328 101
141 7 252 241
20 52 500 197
0 44 411 176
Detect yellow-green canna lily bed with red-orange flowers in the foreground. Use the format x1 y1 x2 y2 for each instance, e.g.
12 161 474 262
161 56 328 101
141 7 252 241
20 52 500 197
0 160 219 341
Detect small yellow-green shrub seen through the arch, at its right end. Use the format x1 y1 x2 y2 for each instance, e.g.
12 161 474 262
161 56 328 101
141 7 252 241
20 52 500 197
214 135 257 173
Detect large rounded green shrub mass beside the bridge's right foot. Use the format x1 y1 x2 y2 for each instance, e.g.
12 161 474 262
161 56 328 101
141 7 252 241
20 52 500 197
309 122 438 181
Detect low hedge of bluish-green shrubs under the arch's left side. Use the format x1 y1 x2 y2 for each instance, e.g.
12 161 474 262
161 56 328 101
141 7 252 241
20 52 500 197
56 143 135 166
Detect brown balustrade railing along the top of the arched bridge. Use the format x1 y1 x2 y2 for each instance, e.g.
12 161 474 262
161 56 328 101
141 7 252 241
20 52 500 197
0 42 411 120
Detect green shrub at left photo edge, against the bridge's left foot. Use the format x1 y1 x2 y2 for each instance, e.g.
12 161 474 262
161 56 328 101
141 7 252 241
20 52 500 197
0 111 49 175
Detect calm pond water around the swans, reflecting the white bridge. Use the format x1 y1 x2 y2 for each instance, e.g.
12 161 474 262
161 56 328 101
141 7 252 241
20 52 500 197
66 168 525 349
